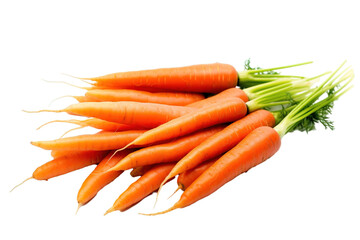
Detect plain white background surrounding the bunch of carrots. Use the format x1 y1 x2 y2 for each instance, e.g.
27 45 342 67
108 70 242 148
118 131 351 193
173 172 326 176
0 1 360 240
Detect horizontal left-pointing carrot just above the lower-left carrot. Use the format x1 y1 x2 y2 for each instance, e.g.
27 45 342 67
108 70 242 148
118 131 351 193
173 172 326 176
31 130 145 151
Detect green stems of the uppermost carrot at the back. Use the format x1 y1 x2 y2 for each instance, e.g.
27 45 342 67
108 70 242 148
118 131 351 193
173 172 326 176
238 59 312 88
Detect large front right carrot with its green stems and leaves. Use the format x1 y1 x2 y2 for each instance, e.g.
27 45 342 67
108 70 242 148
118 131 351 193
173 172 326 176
143 61 353 215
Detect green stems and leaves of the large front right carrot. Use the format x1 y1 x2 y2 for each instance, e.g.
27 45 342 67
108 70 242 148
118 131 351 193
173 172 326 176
274 62 354 137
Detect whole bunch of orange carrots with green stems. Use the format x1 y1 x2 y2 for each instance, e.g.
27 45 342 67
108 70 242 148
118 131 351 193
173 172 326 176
12 61 354 215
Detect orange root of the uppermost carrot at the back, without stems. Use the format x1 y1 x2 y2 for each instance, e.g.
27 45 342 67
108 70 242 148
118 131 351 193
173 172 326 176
87 63 238 93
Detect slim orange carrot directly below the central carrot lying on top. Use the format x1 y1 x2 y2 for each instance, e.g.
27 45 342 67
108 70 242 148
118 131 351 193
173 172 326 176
109 125 225 171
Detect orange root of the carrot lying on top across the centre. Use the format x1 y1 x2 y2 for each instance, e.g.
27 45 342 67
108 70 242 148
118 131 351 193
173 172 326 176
129 98 247 146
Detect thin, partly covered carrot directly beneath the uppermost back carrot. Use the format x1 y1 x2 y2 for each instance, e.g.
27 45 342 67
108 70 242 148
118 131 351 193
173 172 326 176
85 89 204 106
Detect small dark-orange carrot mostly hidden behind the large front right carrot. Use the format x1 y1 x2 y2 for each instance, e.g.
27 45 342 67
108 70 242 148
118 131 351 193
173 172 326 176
177 159 217 191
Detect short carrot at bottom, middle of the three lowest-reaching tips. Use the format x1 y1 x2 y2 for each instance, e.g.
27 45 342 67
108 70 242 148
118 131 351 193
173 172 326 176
105 163 174 215
